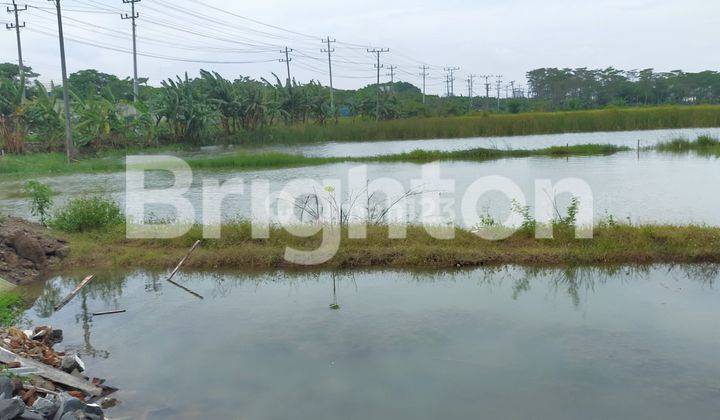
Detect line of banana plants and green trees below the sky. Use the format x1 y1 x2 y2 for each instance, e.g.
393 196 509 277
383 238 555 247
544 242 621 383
0 63 720 152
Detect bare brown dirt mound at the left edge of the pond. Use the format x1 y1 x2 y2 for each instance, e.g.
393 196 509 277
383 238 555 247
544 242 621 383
0 217 69 284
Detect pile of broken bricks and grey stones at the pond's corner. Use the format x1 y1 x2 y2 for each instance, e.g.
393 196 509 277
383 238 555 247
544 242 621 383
0 327 115 420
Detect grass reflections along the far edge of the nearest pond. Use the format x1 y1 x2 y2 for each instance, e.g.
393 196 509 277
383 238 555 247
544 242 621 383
30 264 720 310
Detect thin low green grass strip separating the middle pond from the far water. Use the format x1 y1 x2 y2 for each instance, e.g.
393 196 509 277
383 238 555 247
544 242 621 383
0 144 629 178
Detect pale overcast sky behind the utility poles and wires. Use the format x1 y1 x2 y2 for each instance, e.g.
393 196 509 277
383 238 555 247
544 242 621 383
0 0 720 94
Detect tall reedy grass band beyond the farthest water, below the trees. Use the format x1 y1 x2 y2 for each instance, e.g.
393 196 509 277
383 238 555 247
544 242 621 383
240 105 720 145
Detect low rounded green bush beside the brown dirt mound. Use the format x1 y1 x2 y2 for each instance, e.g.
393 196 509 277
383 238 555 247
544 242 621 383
50 197 125 233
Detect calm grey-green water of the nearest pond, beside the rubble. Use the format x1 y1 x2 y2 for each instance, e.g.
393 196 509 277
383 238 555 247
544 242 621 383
19 266 720 420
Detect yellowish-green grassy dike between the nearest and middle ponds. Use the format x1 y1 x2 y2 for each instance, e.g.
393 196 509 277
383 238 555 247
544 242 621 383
64 222 720 270
